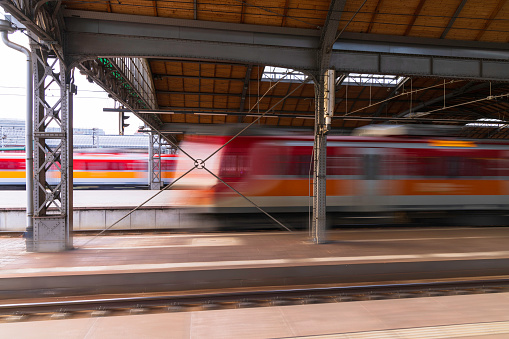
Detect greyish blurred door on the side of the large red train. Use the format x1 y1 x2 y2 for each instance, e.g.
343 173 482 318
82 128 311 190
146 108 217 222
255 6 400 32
359 148 385 211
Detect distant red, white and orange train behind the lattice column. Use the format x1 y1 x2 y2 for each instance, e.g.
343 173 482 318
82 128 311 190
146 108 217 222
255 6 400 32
0 149 177 189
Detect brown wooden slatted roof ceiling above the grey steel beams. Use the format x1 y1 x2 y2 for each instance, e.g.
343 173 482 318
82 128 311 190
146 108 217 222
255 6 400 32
63 0 509 138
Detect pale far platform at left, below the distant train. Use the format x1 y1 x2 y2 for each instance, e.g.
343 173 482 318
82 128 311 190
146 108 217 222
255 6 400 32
0 189 207 232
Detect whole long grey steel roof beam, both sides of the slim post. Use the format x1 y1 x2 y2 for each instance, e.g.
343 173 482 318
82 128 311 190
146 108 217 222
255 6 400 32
64 10 509 81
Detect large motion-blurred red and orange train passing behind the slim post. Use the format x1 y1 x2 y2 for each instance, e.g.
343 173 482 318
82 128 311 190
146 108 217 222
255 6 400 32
174 128 509 226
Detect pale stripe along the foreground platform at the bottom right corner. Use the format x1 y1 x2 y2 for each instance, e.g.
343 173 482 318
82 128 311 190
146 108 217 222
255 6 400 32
292 321 509 339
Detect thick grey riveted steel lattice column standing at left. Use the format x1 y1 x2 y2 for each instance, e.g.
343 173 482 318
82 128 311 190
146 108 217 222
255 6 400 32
27 45 74 252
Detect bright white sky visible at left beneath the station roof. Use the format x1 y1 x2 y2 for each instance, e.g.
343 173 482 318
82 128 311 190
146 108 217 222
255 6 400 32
0 7 143 134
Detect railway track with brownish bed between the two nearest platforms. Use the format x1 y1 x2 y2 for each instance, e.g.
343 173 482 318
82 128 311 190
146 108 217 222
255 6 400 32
0 279 509 323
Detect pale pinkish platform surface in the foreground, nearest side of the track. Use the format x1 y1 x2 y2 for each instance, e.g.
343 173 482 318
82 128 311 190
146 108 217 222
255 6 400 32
0 293 509 339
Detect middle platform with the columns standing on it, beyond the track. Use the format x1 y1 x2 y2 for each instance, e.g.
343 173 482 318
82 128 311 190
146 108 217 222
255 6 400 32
0 228 509 298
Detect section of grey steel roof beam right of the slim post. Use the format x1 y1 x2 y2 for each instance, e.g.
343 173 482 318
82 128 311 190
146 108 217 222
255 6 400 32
331 33 509 81
